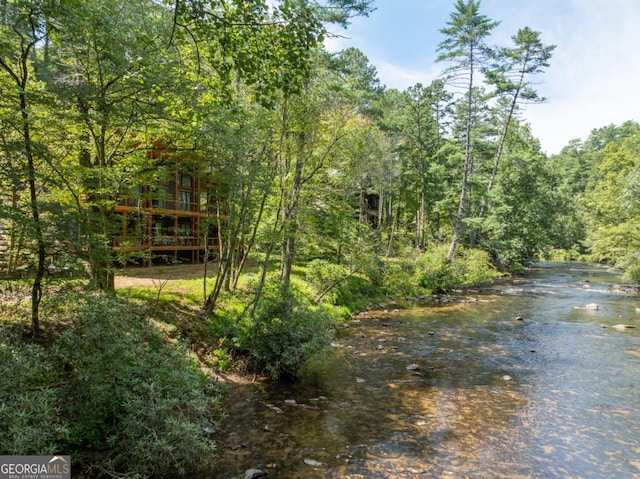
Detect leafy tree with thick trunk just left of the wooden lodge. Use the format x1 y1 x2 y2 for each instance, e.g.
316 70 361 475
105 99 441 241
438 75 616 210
49 0 176 290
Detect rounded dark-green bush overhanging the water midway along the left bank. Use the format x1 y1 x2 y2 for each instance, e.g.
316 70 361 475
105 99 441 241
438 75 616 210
241 276 333 379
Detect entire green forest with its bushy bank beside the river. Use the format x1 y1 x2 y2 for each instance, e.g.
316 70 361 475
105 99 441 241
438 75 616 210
0 0 640 477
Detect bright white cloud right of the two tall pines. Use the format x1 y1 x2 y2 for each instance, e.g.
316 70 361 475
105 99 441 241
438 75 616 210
526 0 640 153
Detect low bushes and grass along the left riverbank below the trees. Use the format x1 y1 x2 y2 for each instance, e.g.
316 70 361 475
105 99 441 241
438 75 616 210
0 249 496 477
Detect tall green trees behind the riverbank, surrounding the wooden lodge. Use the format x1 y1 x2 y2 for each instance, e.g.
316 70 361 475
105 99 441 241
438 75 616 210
0 0 639 338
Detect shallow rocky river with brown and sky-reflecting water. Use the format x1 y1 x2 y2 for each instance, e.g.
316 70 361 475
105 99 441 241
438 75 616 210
210 263 640 479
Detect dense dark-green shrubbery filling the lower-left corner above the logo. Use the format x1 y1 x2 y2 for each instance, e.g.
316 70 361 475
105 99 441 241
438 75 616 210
0 295 218 477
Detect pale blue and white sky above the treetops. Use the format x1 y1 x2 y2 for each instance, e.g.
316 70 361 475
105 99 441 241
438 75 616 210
325 0 640 154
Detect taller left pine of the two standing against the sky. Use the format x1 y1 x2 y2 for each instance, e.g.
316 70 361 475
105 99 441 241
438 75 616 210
437 0 499 260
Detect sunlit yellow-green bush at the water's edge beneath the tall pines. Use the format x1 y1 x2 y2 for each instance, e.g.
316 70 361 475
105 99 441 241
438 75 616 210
414 245 497 292
